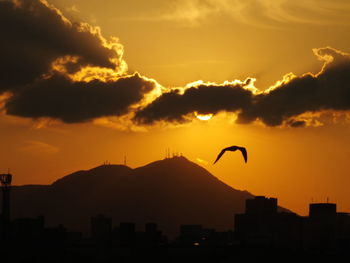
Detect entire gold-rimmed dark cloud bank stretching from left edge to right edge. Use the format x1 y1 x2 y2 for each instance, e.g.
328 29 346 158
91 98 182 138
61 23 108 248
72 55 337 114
0 0 350 127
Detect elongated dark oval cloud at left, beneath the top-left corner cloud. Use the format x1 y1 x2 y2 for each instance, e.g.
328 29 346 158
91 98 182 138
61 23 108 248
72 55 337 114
5 74 155 123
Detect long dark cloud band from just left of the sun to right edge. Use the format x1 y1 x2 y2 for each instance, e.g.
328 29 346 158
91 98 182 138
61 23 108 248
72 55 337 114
135 48 350 127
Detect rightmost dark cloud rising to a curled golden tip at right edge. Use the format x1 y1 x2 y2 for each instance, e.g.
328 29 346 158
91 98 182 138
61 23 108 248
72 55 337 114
238 48 350 126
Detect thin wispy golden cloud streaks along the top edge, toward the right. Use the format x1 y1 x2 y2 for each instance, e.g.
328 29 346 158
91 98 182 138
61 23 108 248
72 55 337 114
117 0 350 28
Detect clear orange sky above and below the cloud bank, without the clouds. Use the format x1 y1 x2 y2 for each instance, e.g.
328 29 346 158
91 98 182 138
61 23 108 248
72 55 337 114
0 0 350 215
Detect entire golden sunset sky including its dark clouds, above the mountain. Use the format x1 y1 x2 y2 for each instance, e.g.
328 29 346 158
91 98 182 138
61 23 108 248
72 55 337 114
0 0 350 215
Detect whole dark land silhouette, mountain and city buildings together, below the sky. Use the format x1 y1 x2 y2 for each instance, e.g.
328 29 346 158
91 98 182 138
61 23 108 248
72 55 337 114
0 156 350 262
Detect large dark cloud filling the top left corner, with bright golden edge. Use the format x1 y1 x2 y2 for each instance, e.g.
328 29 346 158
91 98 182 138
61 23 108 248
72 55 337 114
0 0 122 92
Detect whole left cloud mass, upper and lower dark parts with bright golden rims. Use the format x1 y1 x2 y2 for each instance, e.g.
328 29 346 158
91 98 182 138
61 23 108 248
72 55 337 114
0 0 155 123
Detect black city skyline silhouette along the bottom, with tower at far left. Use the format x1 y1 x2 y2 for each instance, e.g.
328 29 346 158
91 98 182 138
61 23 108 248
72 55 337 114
0 175 350 262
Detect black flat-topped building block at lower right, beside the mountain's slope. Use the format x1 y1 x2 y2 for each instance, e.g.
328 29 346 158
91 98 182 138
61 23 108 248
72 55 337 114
235 196 350 253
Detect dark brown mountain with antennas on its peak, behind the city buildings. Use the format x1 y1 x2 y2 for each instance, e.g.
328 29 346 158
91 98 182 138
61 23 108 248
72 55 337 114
6 157 288 236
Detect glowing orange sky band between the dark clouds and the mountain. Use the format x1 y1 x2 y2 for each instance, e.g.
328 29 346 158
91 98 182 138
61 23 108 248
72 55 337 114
4 108 350 218
